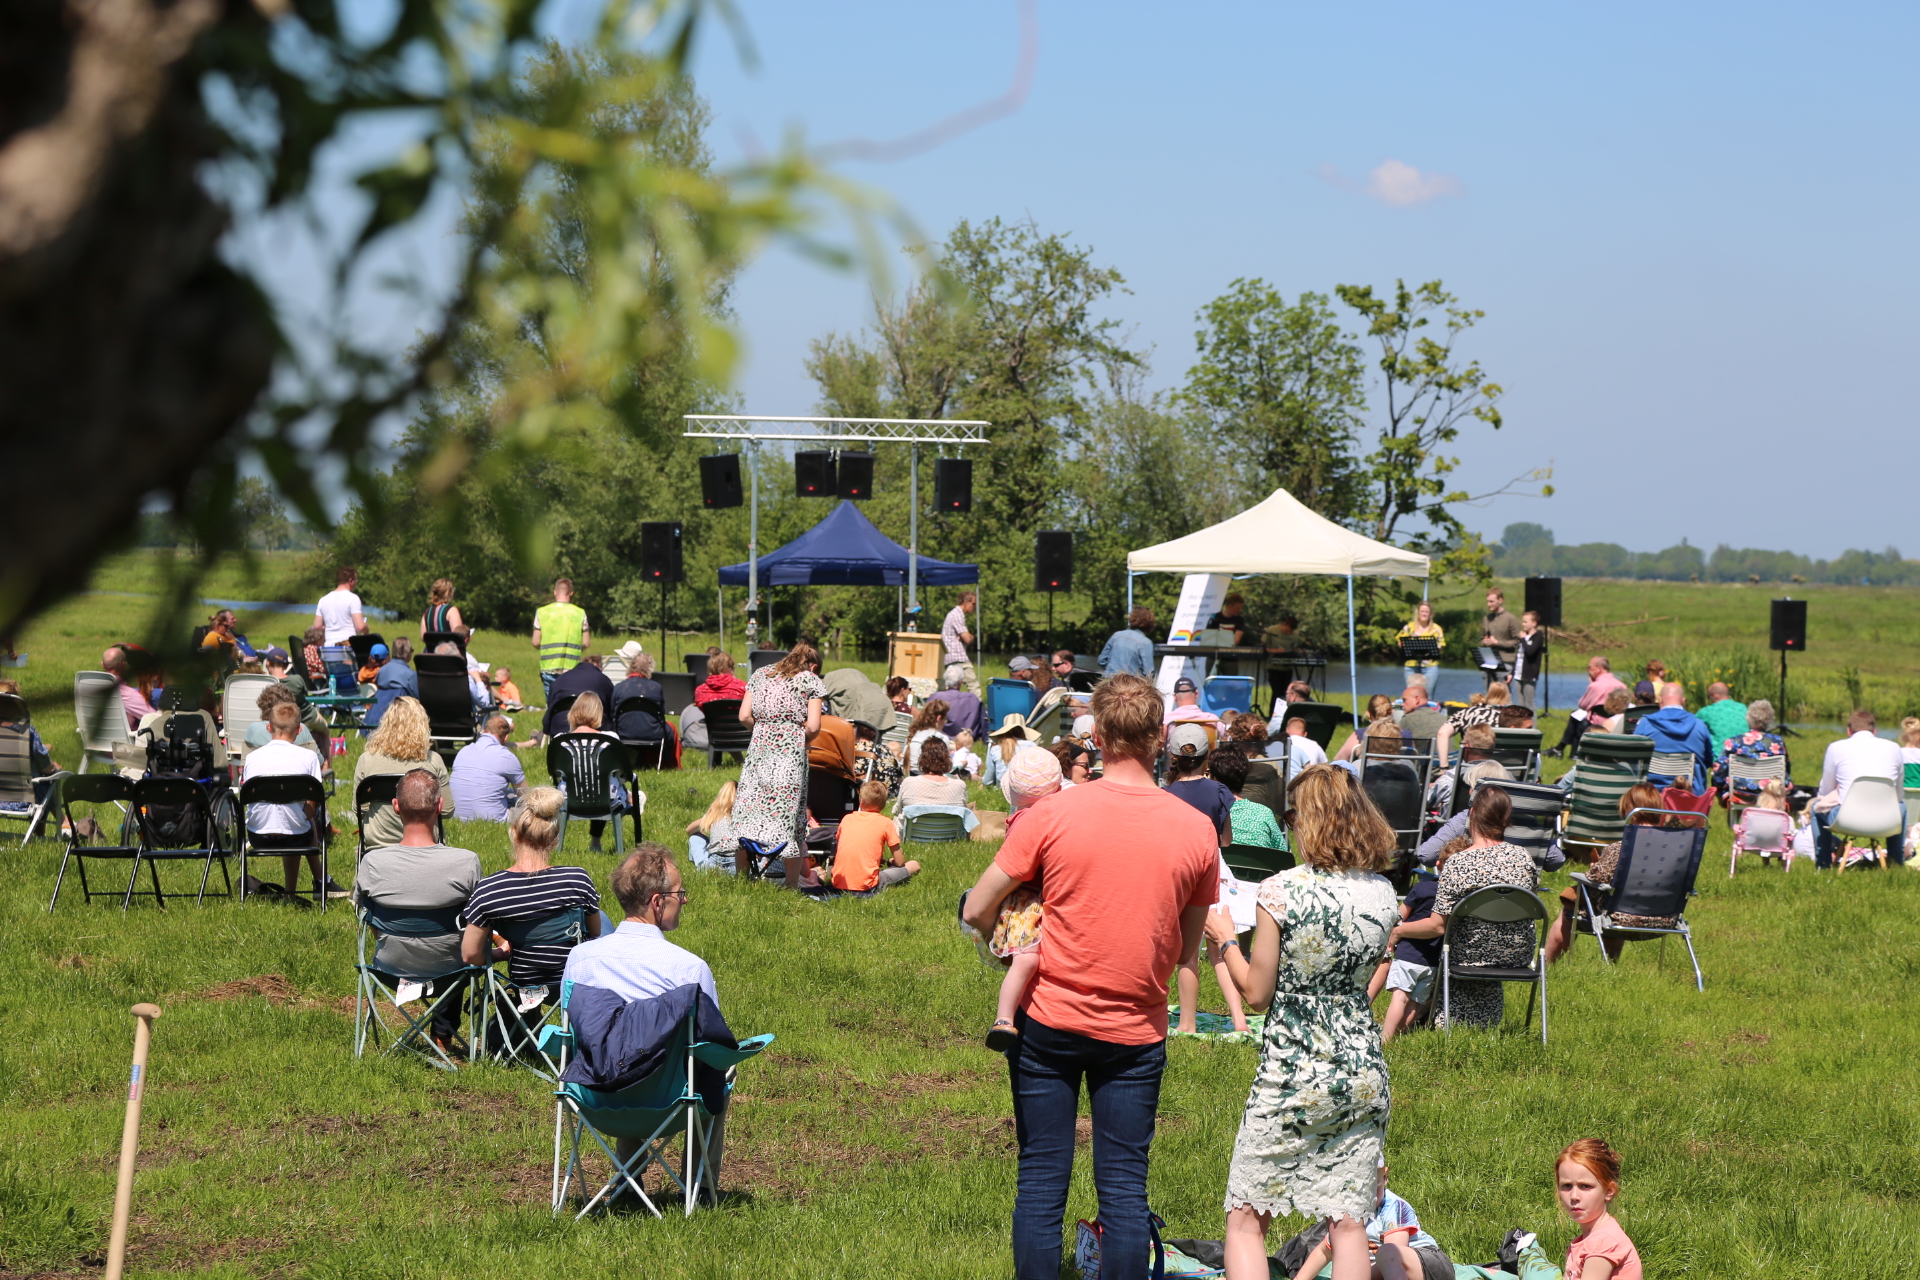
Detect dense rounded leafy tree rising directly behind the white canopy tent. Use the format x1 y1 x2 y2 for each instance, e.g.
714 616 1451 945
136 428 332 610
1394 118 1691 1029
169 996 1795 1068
1181 280 1367 522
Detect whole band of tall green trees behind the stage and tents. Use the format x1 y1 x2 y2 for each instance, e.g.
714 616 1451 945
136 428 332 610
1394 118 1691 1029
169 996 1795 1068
328 52 1551 652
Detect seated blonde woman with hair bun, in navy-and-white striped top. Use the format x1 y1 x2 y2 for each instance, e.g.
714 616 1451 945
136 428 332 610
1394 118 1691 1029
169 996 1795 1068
455 787 601 1050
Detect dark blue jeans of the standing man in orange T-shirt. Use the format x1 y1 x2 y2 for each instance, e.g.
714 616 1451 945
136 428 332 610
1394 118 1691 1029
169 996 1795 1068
1006 1011 1167 1280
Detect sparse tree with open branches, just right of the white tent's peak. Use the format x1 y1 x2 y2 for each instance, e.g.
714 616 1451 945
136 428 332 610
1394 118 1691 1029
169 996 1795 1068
1334 280 1553 578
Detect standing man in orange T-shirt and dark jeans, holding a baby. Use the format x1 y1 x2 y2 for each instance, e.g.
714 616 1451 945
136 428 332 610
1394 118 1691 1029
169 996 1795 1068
966 676 1219 1280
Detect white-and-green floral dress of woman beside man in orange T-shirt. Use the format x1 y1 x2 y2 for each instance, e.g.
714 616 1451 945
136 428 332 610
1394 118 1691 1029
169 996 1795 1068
1227 865 1400 1222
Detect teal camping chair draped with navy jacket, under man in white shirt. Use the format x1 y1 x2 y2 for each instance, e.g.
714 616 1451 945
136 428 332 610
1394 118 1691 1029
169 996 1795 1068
540 983 774 1221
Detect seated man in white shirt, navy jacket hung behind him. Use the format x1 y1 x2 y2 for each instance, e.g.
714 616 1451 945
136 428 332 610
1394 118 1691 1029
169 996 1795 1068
564 841 726 1186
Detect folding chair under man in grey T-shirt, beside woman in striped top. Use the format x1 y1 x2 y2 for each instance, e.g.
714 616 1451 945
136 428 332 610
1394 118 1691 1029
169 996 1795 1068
353 900 486 1071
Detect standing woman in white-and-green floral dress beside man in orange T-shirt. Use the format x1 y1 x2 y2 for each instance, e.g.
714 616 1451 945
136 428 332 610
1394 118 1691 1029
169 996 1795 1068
1206 764 1400 1280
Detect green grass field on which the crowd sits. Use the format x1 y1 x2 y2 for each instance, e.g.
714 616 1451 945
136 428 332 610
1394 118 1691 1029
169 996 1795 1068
11 580 1920 1280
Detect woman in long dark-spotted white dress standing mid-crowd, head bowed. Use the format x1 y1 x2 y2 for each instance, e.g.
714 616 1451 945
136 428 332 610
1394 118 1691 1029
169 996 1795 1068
733 645 826 889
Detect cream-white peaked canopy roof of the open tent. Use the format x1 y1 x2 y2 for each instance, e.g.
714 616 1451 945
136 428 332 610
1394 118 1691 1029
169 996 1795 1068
1127 489 1428 578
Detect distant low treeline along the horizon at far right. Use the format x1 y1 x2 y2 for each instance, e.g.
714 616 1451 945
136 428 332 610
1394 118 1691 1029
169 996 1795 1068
1494 524 1920 587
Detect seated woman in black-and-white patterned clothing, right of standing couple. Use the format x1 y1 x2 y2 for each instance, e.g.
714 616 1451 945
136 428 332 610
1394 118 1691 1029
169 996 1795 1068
1428 787 1540 1027
